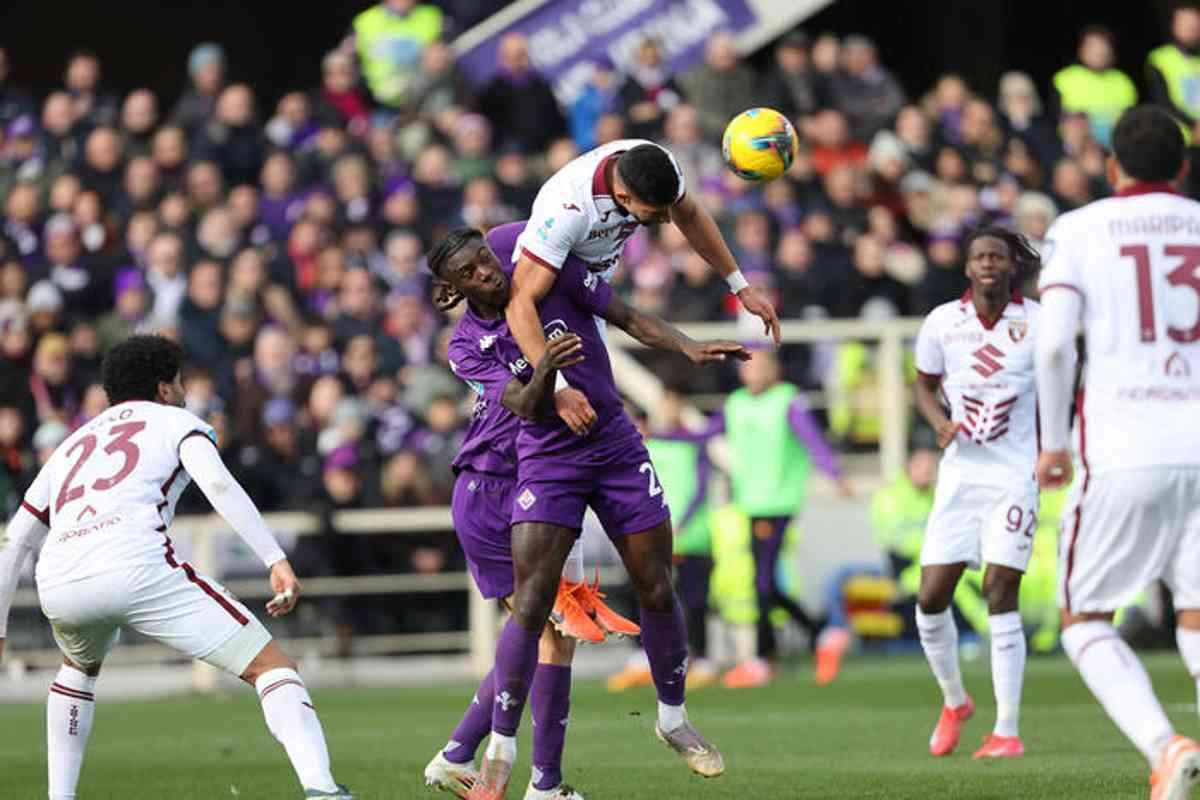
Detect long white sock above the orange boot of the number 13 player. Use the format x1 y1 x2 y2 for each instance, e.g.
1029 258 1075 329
1062 621 1175 769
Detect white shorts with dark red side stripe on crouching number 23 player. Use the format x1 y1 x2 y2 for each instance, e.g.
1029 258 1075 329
38 563 271 675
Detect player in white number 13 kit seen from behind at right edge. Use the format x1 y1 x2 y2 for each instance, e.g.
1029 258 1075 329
1037 107 1200 800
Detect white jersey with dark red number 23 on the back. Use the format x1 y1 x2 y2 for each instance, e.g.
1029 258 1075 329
23 401 216 588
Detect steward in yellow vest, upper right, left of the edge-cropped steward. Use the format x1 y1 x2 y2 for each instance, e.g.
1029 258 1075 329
1054 25 1138 148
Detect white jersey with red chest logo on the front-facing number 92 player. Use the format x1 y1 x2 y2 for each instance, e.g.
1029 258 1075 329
916 290 1040 488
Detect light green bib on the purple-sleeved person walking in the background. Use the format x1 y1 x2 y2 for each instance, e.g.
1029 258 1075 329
725 384 811 517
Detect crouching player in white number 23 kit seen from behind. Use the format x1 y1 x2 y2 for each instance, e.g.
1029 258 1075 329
0 336 354 800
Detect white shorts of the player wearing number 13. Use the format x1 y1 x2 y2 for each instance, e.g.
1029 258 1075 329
1058 467 1200 614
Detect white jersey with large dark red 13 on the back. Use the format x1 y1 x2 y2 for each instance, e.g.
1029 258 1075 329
1040 186 1200 471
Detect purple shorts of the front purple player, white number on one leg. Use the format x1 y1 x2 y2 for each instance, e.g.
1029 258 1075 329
512 441 671 539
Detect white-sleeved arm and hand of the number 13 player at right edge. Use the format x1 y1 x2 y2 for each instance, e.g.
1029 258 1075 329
1033 284 1084 488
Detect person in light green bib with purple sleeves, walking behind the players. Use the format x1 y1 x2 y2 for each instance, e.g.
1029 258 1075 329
710 350 852 686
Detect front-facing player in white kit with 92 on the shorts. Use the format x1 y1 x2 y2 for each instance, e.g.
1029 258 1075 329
917 228 1040 758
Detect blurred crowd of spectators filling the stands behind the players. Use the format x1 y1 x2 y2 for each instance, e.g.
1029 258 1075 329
0 0 1200 527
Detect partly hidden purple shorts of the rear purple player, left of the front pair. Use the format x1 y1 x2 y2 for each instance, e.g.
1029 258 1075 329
450 471 516 600
